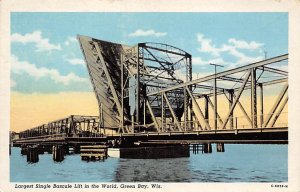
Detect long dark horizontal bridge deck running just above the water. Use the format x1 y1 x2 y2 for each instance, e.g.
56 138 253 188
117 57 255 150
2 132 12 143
13 127 288 145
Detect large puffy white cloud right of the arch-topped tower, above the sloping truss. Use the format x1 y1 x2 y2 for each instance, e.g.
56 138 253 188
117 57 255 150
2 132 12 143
193 33 264 67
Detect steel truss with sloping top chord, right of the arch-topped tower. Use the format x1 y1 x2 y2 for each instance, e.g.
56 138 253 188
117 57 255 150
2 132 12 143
147 54 288 131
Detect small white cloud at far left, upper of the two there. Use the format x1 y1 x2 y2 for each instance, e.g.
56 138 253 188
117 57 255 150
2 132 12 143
11 31 61 52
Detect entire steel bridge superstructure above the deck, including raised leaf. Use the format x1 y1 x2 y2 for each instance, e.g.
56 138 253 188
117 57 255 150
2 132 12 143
16 36 288 138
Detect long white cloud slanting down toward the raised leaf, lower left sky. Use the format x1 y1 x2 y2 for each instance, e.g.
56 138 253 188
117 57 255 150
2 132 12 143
11 55 88 85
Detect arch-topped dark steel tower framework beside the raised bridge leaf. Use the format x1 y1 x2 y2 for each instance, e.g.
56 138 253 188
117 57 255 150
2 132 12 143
121 43 192 133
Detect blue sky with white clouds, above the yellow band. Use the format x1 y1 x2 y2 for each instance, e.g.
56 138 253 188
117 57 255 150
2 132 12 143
11 13 288 93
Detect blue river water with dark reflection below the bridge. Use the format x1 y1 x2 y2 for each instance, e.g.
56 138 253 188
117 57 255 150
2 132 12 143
10 144 288 182
